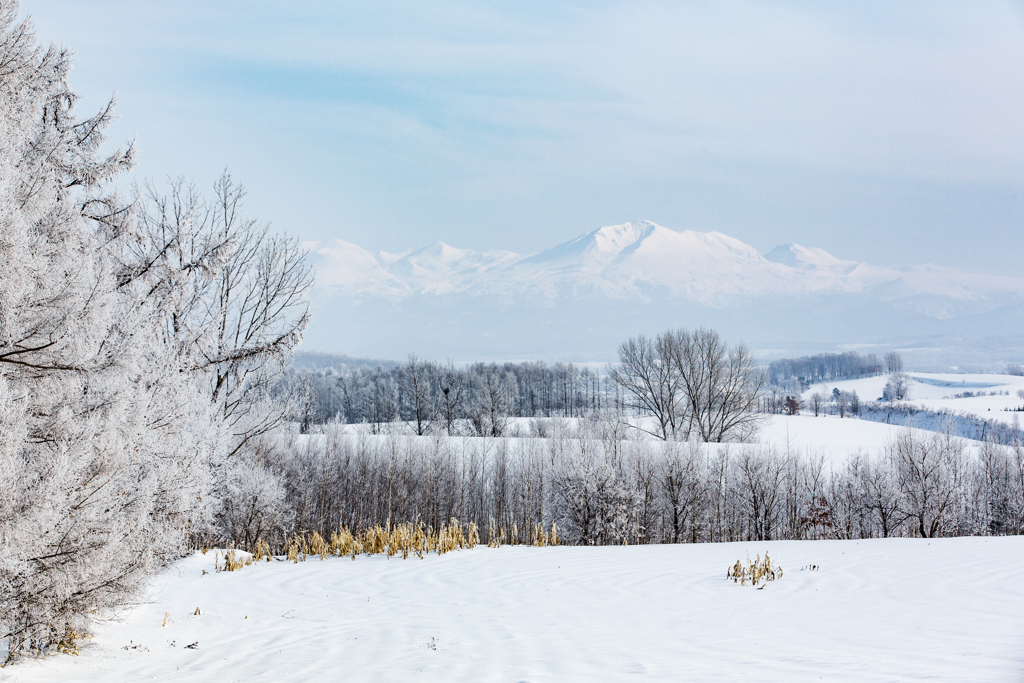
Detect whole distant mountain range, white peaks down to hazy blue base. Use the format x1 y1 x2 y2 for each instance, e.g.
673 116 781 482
305 221 1024 365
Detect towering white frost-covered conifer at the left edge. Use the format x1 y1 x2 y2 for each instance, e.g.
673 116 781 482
0 0 218 656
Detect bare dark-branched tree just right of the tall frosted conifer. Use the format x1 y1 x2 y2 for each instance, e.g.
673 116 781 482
130 171 312 453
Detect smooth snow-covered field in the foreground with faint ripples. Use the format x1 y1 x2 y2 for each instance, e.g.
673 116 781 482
9 538 1024 683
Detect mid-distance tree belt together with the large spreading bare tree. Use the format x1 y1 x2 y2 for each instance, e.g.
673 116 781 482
276 329 767 441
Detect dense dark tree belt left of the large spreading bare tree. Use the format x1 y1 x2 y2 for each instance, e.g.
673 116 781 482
275 355 623 436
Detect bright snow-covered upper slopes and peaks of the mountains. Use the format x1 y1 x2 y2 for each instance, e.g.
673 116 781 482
304 220 1024 303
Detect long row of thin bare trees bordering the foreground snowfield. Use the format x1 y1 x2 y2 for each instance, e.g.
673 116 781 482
228 419 1024 549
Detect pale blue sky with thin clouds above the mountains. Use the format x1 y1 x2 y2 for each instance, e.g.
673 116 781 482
22 0 1024 274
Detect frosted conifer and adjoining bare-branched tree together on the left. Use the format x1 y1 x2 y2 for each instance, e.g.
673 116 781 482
0 5 311 657
